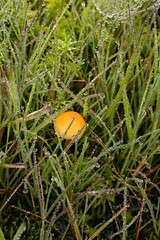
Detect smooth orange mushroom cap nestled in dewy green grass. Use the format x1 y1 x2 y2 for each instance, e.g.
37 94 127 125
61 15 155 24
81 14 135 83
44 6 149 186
55 111 85 140
